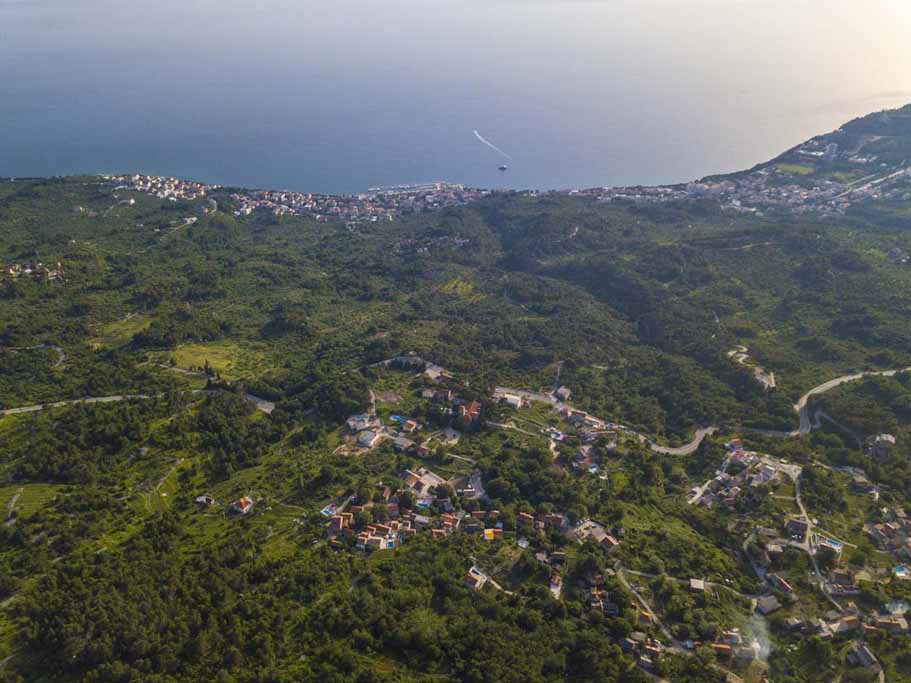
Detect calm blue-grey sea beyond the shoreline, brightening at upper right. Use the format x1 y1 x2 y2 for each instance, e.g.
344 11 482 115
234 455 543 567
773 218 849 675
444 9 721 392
0 0 911 193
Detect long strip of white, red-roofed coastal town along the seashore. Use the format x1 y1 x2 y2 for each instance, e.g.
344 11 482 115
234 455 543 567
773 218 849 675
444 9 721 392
105 114 911 225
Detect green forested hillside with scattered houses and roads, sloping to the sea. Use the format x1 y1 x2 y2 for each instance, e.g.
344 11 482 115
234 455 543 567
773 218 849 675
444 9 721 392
0 108 911 681
